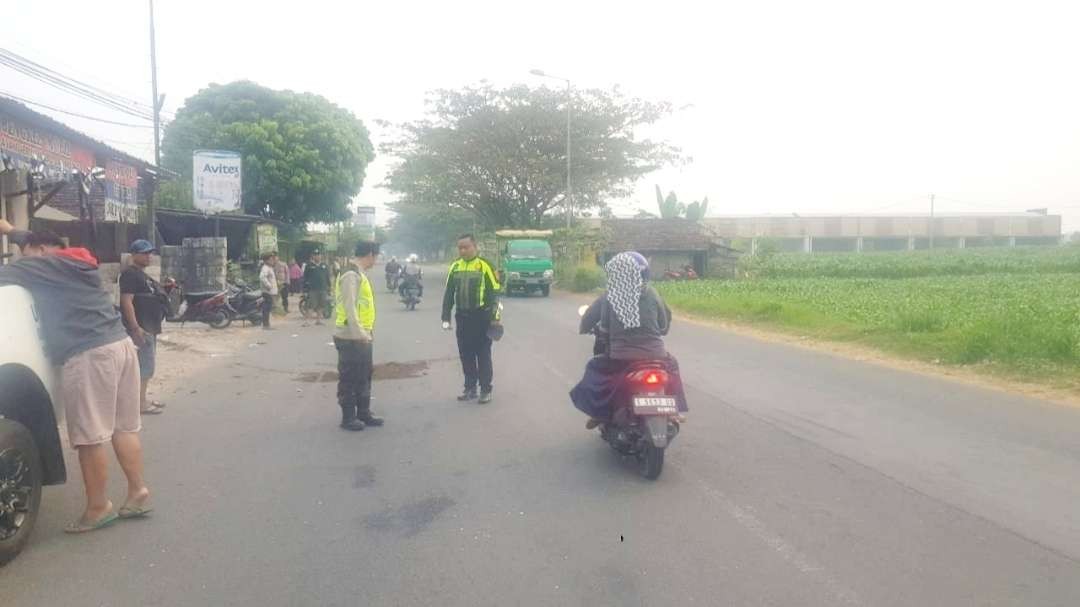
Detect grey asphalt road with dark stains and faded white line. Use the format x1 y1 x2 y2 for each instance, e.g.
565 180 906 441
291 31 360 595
0 275 1080 606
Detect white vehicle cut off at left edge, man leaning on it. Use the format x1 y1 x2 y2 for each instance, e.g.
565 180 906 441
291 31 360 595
0 286 67 565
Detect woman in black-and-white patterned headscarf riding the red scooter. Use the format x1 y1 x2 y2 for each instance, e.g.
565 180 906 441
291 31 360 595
570 252 687 430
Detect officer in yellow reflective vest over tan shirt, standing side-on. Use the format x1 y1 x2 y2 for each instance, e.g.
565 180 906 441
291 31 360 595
334 242 382 431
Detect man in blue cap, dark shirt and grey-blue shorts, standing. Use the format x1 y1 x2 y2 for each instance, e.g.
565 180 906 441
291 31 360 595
120 240 165 415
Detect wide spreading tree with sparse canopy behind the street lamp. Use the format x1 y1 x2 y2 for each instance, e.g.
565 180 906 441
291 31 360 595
383 85 678 227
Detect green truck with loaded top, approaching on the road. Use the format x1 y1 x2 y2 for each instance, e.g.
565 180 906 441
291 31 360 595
495 230 555 297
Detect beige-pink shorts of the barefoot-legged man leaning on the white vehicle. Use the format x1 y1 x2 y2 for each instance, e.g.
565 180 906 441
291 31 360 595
60 337 143 447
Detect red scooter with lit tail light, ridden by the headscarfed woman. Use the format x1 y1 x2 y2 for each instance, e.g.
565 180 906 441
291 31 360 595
578 306 684 481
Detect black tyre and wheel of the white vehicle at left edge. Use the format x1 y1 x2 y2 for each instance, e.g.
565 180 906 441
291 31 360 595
0 419 42 565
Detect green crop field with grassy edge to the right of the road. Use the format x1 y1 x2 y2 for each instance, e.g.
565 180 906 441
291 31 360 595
658 247 1080 388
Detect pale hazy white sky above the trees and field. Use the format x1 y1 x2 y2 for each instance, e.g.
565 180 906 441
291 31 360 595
8 0 1080 229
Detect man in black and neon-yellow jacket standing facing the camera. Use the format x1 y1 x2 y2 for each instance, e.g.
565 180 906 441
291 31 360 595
443 234 501 403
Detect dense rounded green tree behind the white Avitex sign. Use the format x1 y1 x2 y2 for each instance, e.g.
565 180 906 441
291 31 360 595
162 81 375 224
